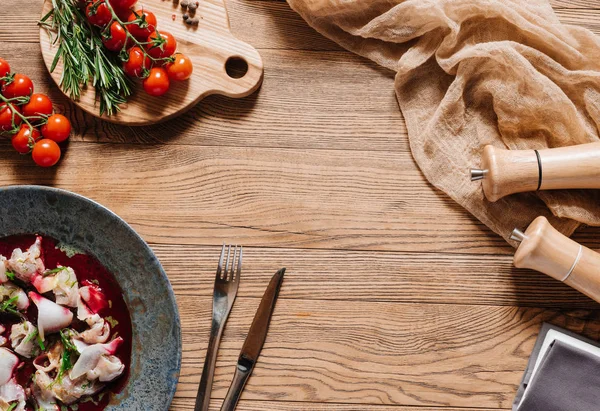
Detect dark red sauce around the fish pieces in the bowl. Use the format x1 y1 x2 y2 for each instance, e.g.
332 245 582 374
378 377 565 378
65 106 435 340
0 235 132 411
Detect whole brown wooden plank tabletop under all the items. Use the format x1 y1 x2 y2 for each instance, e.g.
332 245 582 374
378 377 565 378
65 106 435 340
0 0 600 411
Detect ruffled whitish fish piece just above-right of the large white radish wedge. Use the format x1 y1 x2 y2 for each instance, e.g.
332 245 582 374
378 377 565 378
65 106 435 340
31 266 79 307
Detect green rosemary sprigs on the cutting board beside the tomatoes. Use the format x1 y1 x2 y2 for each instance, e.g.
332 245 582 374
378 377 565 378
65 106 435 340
40 0 132 116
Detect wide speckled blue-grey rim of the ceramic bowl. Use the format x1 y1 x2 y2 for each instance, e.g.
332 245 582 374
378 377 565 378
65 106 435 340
0 186 181 411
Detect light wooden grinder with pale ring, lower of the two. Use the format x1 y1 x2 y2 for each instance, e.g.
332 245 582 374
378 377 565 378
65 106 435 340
511 217 600 302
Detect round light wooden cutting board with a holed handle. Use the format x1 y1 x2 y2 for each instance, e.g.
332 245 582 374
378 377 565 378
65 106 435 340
40 0 263 126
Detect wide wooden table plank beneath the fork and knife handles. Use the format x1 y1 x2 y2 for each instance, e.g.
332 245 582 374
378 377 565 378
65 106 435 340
171 298 600 408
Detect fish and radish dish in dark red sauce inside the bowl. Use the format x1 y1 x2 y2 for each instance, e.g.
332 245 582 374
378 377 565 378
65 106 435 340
0 235 132 411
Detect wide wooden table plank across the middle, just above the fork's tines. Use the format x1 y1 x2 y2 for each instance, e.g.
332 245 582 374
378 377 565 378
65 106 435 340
0 142 512 253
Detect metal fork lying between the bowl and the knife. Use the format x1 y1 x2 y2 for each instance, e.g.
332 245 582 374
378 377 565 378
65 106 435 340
194 244 243 411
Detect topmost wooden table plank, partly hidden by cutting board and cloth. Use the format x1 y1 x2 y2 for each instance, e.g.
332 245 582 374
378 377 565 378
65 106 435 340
5 0 600 47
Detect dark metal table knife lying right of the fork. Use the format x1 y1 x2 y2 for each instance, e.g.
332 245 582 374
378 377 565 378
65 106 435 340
221 268 285 411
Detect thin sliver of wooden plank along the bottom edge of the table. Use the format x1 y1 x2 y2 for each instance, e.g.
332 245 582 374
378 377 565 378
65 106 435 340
171 398 497 411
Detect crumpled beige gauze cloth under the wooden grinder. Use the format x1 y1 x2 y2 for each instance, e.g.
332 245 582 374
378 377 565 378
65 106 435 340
288 0 600 245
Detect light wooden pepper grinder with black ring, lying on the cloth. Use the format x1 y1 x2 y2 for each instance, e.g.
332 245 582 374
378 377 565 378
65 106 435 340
471 142 600 202
